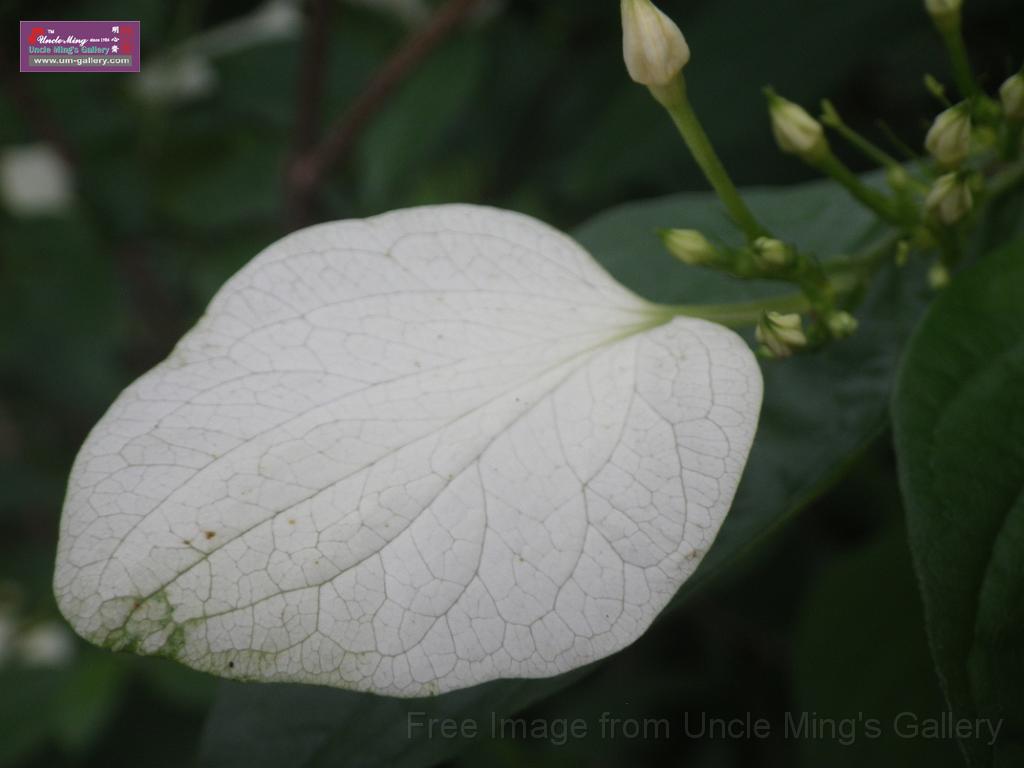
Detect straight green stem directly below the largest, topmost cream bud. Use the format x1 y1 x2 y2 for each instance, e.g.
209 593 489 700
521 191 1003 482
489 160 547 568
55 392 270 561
650 75 768 242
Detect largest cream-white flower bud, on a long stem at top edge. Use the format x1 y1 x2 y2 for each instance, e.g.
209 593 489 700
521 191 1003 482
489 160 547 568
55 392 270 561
622 0 690 86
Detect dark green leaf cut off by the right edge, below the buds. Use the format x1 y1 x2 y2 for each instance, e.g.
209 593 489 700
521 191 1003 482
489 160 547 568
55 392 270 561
892 241 1024 766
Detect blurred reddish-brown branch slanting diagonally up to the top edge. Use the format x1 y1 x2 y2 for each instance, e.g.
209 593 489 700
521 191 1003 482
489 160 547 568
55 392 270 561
288 0 479 225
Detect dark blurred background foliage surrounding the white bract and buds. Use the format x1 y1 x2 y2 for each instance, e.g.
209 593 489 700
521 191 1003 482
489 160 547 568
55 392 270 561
0 0 1024 767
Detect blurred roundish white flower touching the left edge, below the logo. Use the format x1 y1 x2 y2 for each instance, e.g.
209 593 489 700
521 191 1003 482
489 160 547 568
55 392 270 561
0 143 73 216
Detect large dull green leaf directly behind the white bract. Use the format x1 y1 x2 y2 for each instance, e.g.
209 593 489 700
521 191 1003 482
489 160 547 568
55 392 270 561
201 176 924 768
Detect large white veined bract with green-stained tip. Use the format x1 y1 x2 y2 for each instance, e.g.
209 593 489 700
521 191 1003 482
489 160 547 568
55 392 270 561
55 206 761 696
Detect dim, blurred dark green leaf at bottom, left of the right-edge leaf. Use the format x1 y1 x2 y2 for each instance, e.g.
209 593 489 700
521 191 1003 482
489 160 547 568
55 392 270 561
794 518 963 768
